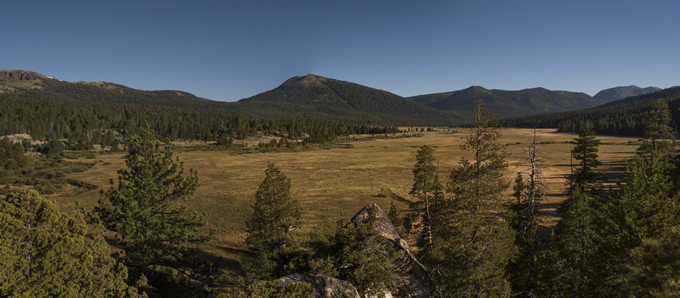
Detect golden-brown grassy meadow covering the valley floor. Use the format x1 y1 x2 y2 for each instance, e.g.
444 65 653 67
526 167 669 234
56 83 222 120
53 129 637 270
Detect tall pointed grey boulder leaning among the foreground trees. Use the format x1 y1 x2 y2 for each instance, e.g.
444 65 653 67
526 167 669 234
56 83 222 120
351 204 434 298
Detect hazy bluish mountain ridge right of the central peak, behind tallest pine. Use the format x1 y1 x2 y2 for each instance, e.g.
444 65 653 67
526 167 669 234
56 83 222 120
410 86 605 118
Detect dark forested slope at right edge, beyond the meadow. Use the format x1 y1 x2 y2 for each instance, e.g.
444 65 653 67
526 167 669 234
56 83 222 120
499 87 680 136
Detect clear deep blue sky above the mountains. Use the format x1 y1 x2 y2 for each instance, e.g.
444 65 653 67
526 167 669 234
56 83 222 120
5 0 680 101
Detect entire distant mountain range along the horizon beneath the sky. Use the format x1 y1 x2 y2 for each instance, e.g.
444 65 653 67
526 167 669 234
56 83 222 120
0 70 658 125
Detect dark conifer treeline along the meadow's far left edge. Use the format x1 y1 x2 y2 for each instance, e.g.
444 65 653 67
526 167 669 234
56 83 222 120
0 96 399 149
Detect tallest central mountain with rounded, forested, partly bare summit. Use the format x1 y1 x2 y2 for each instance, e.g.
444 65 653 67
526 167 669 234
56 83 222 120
237 74 469 125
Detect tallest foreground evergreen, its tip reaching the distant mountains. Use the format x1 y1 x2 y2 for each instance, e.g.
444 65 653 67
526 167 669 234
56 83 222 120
435 102 516 297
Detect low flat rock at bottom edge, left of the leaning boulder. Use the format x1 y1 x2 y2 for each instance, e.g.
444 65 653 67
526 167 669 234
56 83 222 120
279 273 361 298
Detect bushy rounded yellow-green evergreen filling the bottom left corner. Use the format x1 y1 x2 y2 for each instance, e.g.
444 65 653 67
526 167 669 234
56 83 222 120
0 190 139 297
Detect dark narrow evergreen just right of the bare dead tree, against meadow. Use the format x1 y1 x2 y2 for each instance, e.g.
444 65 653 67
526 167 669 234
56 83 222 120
571 128 602 189
